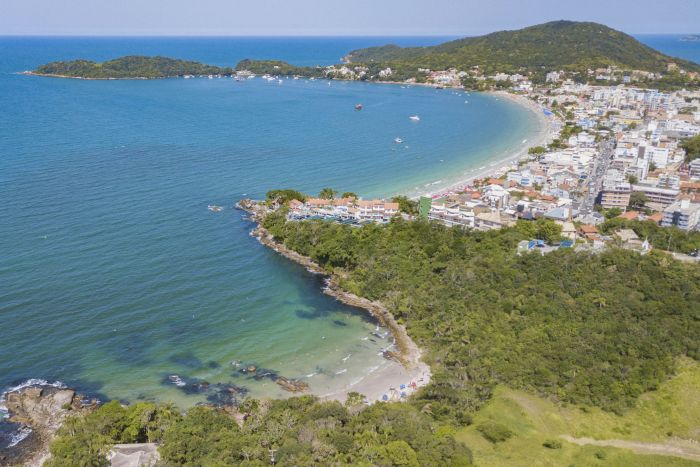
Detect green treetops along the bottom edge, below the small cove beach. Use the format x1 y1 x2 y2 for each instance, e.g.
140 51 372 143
49 394 471 466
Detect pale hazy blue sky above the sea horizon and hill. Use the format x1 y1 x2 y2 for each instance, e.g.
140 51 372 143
0 0 700 36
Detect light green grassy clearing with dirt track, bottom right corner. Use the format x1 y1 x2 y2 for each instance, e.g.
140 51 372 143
458 359 700 467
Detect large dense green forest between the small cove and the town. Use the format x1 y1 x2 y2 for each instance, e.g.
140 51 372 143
265 215 700 414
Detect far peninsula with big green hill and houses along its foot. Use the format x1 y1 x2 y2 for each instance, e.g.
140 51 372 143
236 21 700 90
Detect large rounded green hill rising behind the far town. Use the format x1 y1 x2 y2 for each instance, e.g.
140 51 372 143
346 21 700 72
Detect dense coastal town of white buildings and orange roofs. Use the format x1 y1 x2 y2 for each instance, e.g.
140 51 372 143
272 66 700 257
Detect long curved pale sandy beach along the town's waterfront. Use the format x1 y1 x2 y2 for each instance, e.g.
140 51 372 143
412 91 560 198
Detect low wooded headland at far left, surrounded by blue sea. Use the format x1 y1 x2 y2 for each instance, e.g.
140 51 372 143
34 55 233 79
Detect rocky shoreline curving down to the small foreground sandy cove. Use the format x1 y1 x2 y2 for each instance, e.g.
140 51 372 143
236 200 432 402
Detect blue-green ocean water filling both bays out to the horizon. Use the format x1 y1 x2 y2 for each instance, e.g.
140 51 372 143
0 33 698 450
